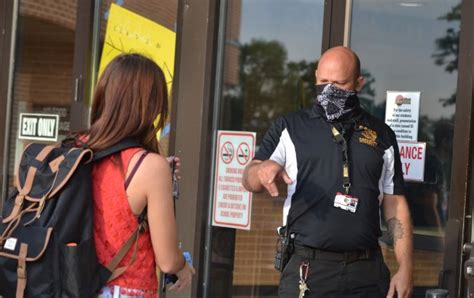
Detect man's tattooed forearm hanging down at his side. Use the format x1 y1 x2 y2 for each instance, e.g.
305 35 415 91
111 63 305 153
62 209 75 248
383 194 413 297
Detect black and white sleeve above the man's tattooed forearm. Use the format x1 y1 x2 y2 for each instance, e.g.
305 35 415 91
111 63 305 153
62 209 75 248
382 129 404 195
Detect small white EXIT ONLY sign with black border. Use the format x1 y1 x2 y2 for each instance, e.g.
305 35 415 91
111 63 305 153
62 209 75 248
18 113 59 142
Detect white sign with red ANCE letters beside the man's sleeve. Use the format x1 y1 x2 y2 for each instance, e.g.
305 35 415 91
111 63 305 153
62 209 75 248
398 141 426 182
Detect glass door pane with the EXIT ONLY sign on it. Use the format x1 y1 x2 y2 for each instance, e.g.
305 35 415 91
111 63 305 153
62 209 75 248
5 0 77 197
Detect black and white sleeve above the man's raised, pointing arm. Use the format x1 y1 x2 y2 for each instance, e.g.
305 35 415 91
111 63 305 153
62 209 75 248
254 117 286 166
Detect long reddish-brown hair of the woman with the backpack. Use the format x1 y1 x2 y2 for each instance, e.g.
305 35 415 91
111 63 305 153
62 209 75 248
87 54 168 153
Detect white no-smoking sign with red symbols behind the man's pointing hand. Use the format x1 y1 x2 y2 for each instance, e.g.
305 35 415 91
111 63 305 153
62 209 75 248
212 130 255 230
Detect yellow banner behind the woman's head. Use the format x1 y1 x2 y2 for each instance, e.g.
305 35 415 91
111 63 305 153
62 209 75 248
99 4 176 140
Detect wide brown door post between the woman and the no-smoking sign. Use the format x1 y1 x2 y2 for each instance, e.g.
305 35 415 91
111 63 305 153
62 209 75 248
166 0 222 297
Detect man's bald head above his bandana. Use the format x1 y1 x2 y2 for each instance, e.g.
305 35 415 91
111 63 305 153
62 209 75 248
316 46 364 91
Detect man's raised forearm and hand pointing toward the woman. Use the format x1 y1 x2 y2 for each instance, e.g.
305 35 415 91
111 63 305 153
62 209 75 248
242 160 292 197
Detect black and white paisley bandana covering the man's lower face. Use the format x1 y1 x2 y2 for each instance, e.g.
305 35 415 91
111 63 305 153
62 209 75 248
316 84 359 122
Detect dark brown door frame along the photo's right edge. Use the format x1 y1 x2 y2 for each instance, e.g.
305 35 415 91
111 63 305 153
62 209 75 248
446 0 474 297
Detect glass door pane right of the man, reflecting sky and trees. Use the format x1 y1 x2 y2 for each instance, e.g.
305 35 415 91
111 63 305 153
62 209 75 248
349 0 461 297
